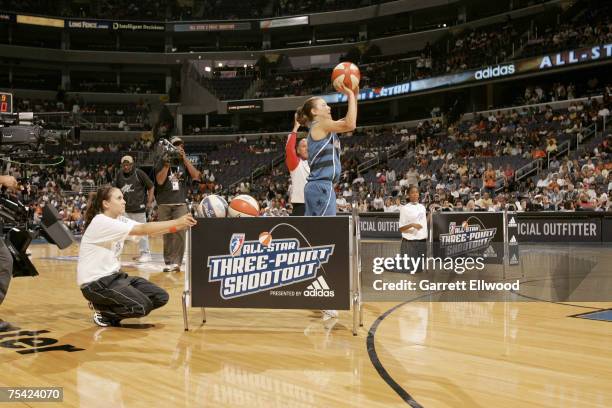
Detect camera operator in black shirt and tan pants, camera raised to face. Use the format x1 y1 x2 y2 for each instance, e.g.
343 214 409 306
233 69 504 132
155 136 200 272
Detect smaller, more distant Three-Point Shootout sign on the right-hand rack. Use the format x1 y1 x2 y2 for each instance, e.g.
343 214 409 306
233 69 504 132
432 212 504 264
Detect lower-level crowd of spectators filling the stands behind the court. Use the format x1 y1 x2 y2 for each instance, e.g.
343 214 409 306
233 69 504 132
5 78 612 232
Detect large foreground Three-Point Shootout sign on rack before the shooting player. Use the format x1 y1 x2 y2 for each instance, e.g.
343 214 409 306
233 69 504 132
190 217 351 310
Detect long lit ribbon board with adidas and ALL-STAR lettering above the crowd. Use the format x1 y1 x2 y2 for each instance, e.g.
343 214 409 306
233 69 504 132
322 43 612 103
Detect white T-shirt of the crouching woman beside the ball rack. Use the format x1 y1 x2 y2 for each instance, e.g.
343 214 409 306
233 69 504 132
77 214 139 286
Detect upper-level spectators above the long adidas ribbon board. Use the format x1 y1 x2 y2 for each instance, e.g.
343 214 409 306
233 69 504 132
256 6 612 100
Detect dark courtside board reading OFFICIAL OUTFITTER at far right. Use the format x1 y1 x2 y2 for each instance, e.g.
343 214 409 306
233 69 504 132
517 214 602 243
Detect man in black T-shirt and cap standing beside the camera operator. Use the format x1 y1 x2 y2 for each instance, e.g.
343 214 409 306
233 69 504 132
115 156 154 262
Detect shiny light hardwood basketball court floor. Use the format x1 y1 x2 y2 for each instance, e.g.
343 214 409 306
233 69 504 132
0 240 612 408
